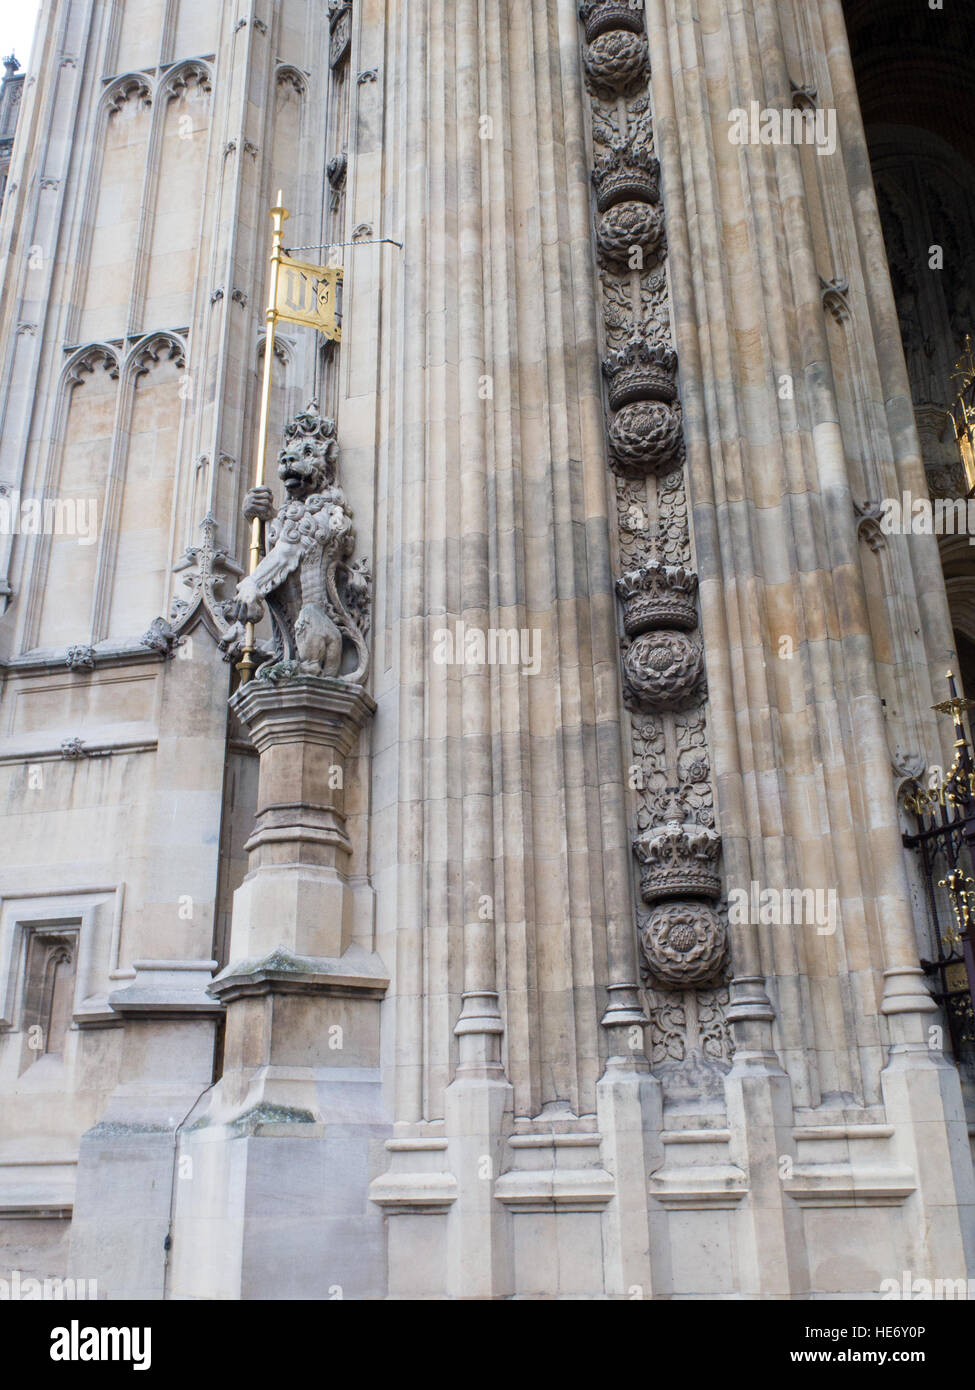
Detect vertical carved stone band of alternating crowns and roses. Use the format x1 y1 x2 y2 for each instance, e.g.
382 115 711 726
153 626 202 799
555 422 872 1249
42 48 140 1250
579 0 727 1023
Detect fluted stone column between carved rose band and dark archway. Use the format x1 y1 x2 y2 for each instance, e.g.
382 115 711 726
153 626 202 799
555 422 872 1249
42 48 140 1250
648 0 971 1297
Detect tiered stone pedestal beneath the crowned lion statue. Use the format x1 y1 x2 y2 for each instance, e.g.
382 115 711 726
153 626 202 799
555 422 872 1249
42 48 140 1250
171 677 389 1298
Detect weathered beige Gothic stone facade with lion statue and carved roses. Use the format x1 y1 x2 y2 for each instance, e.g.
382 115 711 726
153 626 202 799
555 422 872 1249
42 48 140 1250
0 0 975 1300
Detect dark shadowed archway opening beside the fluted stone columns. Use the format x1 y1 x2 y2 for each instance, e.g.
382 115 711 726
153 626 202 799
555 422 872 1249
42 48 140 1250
844 0 975 672
